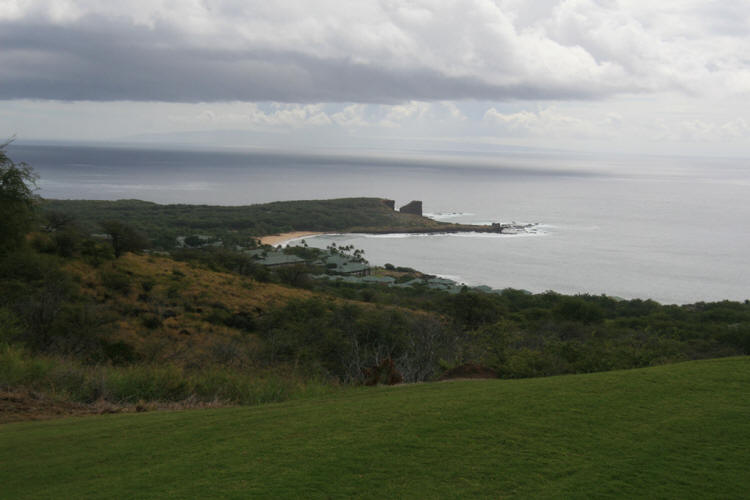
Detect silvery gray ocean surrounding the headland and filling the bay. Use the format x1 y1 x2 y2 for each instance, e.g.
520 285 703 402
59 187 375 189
9 145 750 303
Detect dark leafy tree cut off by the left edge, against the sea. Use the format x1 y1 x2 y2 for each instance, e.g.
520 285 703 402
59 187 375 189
0 141 37 253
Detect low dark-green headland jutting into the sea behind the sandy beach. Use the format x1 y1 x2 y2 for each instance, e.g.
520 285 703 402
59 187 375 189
41 198 482 248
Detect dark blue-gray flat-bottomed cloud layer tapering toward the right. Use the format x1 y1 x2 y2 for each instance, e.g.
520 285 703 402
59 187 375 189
0 19 602 103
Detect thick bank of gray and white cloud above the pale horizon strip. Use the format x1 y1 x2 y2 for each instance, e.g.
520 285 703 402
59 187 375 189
0 0 750 103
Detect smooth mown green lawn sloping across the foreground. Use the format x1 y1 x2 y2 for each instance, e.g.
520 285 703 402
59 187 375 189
0 357 750 499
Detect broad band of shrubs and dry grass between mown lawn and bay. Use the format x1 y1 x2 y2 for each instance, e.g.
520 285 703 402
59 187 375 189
0 227 750 414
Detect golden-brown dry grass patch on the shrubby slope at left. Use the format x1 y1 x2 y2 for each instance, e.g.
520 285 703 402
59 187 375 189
61 254 435 368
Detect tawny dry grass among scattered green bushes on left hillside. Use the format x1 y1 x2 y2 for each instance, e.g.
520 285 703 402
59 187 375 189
68 253 434 363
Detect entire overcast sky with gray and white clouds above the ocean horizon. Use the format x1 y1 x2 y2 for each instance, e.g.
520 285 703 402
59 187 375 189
0 0 750 156
